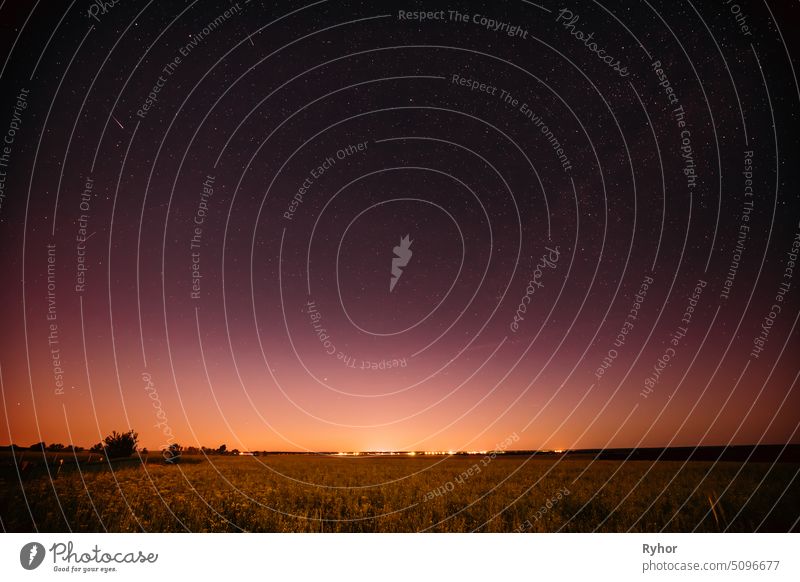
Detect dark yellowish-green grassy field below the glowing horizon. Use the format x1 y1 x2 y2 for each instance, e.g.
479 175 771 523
0 454 800 532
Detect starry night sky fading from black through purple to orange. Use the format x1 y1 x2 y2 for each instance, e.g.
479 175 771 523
0 0 800 451
